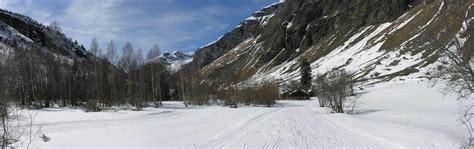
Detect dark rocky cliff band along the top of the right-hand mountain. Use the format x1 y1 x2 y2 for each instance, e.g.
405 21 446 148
192 0 416 68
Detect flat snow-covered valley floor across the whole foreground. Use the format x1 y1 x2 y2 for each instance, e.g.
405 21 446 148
17 80 466 148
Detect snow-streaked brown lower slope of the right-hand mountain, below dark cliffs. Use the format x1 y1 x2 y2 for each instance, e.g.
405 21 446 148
247 2 472 82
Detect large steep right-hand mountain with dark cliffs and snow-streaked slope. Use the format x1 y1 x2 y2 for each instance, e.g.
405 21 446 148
187 0 474 87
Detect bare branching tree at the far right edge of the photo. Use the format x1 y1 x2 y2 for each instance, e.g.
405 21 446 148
431 1 474 148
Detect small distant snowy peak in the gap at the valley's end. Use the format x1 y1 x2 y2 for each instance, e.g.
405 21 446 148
148 51 194 72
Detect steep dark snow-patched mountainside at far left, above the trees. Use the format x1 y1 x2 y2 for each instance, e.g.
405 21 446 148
0 10 94 60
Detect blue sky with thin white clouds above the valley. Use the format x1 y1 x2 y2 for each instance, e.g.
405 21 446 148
0 0 278 51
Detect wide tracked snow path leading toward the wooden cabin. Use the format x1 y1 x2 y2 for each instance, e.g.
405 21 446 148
206 101 460 148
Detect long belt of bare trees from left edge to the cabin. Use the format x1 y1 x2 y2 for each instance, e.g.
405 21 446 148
0 36 279 112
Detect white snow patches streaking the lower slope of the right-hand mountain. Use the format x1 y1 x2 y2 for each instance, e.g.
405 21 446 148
247 3 452 82
